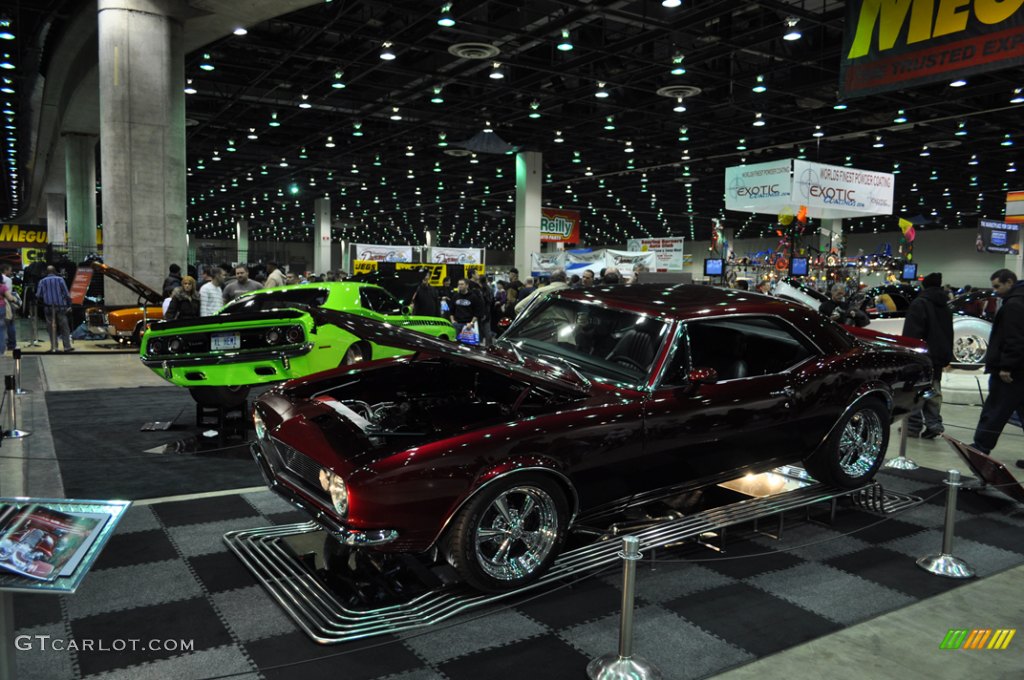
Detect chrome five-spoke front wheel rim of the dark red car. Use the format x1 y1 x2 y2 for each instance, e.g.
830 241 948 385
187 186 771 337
473 486 559 581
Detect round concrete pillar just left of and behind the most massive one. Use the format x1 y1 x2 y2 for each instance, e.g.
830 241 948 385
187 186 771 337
61 132 98 251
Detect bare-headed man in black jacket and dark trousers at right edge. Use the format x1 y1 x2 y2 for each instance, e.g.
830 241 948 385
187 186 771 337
971 269 1024 458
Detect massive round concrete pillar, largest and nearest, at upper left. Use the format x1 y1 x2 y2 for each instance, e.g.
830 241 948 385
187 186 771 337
98 0 189 303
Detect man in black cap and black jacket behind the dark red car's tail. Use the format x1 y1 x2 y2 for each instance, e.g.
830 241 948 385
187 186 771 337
903 273 953 439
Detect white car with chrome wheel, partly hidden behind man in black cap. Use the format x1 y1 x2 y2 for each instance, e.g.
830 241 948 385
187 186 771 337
774 281 998 366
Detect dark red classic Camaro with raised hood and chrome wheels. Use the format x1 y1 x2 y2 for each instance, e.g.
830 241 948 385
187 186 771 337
253 286 932 590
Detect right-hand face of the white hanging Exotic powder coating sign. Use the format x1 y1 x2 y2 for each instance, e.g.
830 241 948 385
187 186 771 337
793 161 895 217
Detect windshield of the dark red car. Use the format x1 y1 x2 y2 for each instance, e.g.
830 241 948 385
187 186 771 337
502 297 668 385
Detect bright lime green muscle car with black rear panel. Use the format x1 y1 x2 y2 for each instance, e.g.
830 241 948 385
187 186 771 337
139 282 455 407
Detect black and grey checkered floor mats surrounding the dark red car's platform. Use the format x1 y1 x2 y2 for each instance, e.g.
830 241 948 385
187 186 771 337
14 470 1024 680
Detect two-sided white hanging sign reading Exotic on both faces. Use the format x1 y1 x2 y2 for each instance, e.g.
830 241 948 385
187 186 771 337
725 157 892 219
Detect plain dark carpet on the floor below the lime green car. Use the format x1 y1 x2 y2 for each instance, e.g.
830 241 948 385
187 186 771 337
46 386 263 500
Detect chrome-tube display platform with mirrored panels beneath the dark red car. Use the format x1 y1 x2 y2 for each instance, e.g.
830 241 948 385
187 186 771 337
224 468 922 644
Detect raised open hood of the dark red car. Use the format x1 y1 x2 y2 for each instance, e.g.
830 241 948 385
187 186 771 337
309 309 591 394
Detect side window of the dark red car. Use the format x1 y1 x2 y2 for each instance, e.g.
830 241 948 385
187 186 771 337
685 316 817 381
